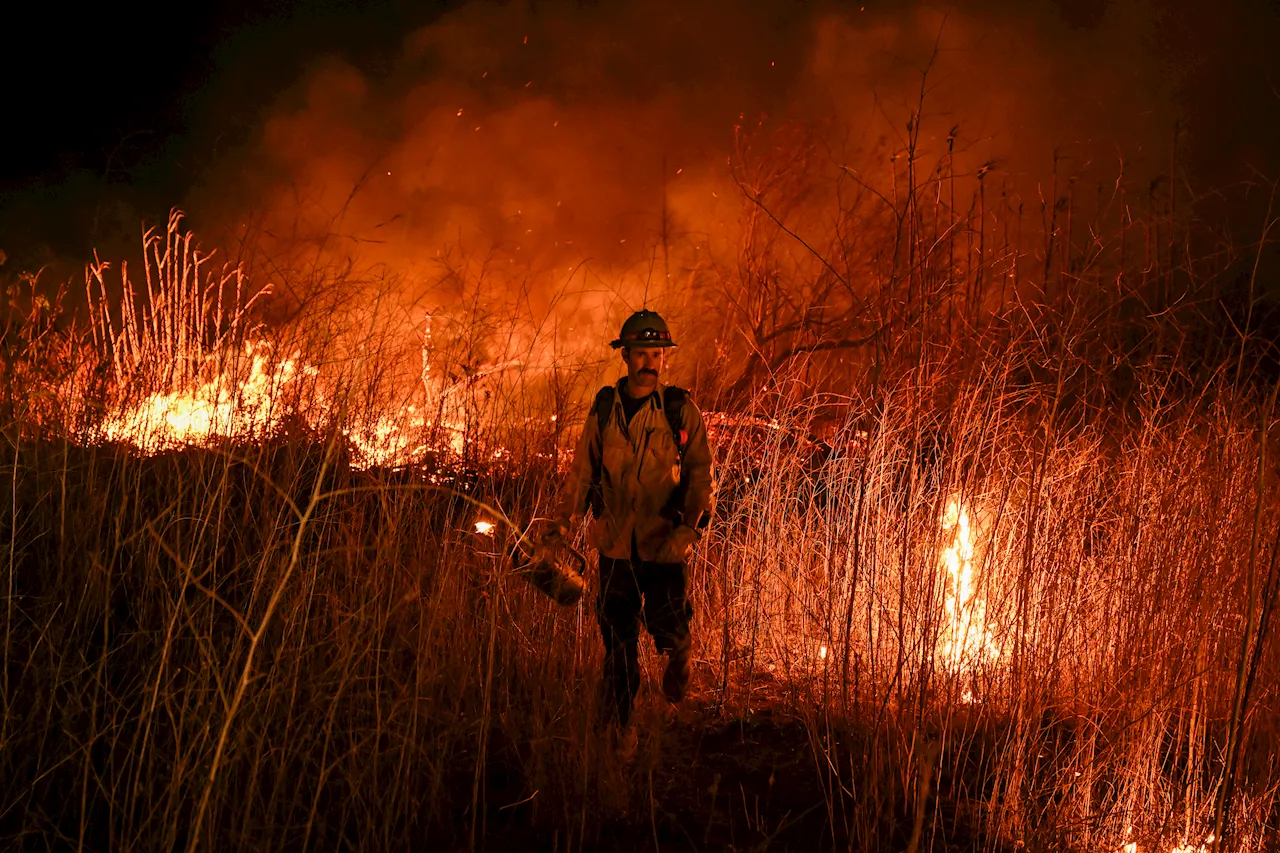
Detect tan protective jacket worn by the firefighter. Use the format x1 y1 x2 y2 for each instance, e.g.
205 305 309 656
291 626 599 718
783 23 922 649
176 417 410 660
558 377 716 562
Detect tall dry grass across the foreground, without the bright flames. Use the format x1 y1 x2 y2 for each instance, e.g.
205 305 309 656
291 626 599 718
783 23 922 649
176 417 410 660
0 350 1280 849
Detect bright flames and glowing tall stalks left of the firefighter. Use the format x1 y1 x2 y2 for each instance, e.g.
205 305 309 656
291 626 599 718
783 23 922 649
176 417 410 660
81 216 483 469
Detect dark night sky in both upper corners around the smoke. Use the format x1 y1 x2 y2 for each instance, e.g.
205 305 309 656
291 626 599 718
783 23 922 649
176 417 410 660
0 0 1280 274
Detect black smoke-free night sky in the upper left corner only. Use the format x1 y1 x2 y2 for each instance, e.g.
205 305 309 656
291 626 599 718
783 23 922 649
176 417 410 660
0 0 456 265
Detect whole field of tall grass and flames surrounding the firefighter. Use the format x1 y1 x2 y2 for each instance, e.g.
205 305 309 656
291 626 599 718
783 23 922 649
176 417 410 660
0 204 1280 853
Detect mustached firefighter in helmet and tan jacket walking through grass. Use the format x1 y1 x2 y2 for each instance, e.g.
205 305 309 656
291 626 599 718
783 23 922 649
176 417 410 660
548 310 714 730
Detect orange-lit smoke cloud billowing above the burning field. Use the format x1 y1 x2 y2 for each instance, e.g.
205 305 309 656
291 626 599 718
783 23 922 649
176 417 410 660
189 0 1179 361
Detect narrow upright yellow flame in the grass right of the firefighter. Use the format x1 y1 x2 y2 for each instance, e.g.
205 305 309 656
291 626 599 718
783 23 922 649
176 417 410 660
938 501 1000 676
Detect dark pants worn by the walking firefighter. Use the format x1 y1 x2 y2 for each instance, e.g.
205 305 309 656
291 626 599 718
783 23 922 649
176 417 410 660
595 553 694 725
